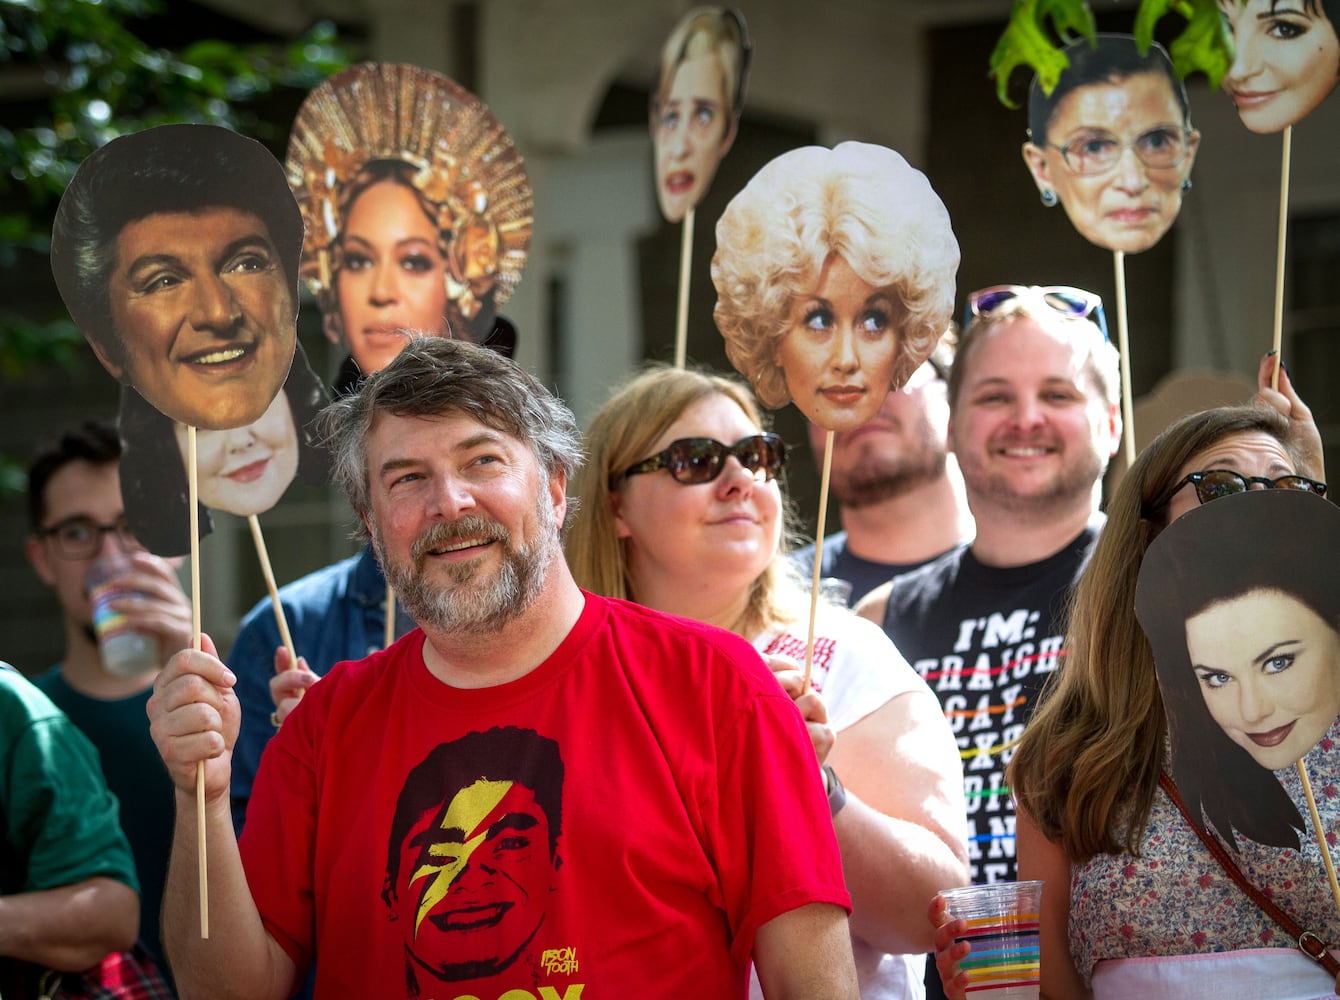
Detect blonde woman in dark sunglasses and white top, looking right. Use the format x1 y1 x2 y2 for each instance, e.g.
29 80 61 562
565 367 967 1000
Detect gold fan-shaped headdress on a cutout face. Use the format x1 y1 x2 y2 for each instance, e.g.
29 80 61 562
287 63 533 343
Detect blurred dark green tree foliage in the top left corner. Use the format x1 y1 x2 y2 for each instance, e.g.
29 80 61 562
0 0 348 367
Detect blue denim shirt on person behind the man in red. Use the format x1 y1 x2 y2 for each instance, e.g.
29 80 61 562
228 546 414 835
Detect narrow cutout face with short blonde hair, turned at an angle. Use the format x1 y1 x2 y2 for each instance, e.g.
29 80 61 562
651 7 750 223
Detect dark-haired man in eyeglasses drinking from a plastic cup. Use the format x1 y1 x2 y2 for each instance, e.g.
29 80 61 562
25 422 192 971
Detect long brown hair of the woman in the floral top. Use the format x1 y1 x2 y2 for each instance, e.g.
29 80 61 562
1006 406 1297 863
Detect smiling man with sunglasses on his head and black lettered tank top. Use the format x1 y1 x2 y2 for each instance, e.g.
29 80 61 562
858 286 1120 882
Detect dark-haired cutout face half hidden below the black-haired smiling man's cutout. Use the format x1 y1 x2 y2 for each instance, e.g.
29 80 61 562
118 345 330 556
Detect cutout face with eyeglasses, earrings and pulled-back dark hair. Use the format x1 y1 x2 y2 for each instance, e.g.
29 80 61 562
1024 35 1201 253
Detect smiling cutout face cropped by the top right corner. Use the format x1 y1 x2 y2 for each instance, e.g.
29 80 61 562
1219 0 1340 133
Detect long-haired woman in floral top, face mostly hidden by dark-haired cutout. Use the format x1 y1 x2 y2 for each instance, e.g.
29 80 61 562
930 357 1340 1000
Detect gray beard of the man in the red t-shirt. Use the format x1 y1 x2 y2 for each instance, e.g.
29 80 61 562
374 499 557 635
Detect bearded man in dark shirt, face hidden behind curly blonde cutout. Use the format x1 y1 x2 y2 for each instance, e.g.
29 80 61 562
795 334 973 606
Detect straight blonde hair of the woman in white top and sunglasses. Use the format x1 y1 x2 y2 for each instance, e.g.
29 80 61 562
564 366 792 638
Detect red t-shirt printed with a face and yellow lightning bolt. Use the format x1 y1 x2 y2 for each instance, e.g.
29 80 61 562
241 594 850 1000
